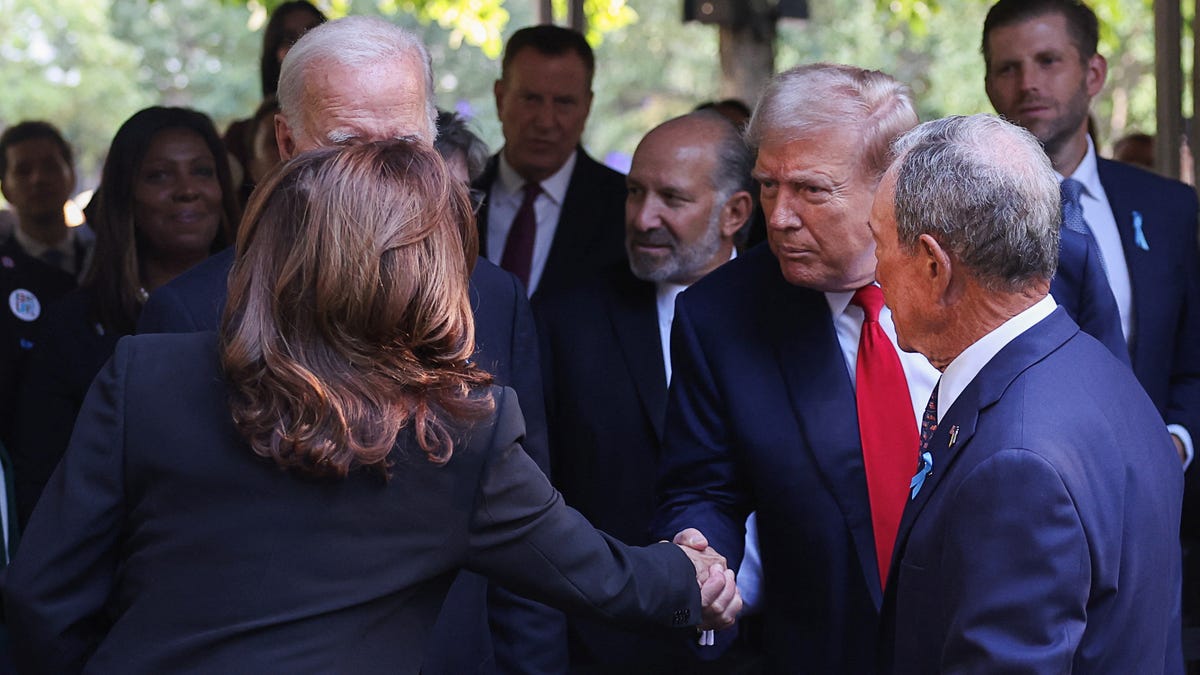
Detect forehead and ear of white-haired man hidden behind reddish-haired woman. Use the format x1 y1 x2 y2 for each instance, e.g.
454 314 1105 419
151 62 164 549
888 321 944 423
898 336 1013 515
275 59 433 161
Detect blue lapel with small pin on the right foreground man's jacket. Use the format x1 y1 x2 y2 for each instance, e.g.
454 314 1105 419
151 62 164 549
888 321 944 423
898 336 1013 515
892 307 1079 569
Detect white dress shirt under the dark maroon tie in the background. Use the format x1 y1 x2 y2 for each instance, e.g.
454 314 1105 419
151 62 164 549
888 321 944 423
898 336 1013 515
487 149 577 295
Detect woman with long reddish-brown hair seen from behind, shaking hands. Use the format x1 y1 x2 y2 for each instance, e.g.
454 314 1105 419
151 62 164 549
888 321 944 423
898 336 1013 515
5 141 739 674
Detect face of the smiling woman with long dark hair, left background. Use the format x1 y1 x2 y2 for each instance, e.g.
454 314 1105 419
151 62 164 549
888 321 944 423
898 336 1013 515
133 129 222 289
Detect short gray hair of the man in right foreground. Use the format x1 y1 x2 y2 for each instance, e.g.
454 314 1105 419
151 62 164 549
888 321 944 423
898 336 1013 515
893 114 1061 293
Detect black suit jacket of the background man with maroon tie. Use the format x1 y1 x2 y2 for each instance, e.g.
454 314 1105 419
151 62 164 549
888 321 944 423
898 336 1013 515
474 148 626 303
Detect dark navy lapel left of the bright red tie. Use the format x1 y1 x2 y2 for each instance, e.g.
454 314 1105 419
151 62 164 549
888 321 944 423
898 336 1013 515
763 276 882 607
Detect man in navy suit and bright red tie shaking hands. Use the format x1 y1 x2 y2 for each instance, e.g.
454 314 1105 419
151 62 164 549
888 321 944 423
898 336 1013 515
653 64 937 673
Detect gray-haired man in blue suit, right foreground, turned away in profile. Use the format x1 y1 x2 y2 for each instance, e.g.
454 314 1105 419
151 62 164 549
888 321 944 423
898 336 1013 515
871 115 1183 674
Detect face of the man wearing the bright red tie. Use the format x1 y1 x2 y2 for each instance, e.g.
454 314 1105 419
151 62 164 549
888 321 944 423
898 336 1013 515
754 129 875 292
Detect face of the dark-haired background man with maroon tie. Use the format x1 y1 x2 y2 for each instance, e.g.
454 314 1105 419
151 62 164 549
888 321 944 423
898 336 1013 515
492 47 592 181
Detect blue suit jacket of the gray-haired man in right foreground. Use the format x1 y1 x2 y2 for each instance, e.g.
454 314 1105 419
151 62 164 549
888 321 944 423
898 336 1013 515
882 310 1183 675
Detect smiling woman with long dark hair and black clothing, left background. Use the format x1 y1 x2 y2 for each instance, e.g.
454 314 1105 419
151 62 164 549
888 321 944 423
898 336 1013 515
12 107 239 522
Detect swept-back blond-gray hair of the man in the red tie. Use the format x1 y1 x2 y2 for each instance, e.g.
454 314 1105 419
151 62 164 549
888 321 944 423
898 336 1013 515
745 64 918 180
